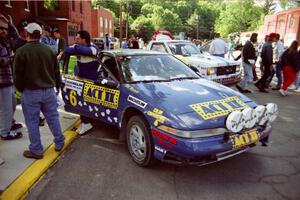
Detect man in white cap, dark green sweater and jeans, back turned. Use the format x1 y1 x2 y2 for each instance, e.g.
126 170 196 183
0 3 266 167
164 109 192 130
14 23 65 159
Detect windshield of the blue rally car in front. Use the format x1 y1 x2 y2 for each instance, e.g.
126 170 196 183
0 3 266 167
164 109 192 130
117 55 199 83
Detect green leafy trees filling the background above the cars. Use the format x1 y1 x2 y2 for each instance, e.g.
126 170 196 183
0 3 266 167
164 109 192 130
94 0 284 38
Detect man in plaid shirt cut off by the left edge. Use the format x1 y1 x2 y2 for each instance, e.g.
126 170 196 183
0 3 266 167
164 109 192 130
0 14 22 144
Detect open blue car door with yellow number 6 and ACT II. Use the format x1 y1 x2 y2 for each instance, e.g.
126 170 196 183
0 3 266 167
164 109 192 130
61 55 120 125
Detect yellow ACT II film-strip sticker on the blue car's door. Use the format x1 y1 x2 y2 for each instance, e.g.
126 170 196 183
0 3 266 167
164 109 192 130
83 83 120 109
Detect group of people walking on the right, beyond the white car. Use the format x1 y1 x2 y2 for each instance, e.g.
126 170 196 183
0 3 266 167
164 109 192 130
236 33 300 96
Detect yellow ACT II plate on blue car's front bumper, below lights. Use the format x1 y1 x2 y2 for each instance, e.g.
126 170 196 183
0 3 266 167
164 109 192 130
230 130 259 149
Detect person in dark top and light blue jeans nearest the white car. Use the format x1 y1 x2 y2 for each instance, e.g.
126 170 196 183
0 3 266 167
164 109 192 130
236 33 257 93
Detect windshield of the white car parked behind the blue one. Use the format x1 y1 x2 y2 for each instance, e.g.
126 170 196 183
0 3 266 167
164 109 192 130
168 42 200 56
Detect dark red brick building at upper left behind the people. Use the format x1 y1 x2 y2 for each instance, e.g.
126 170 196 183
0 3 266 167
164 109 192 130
0 0 114 44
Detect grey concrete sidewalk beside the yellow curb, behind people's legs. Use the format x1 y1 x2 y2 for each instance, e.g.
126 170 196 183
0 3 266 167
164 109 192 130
0 105 79 196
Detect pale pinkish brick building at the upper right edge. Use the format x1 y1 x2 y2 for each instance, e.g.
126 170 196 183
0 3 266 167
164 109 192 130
259 8 300 46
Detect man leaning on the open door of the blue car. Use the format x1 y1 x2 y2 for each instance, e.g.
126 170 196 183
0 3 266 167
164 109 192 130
65 30 99 135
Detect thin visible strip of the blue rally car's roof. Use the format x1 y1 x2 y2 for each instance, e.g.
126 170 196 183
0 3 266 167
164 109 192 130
102 49 169 56
